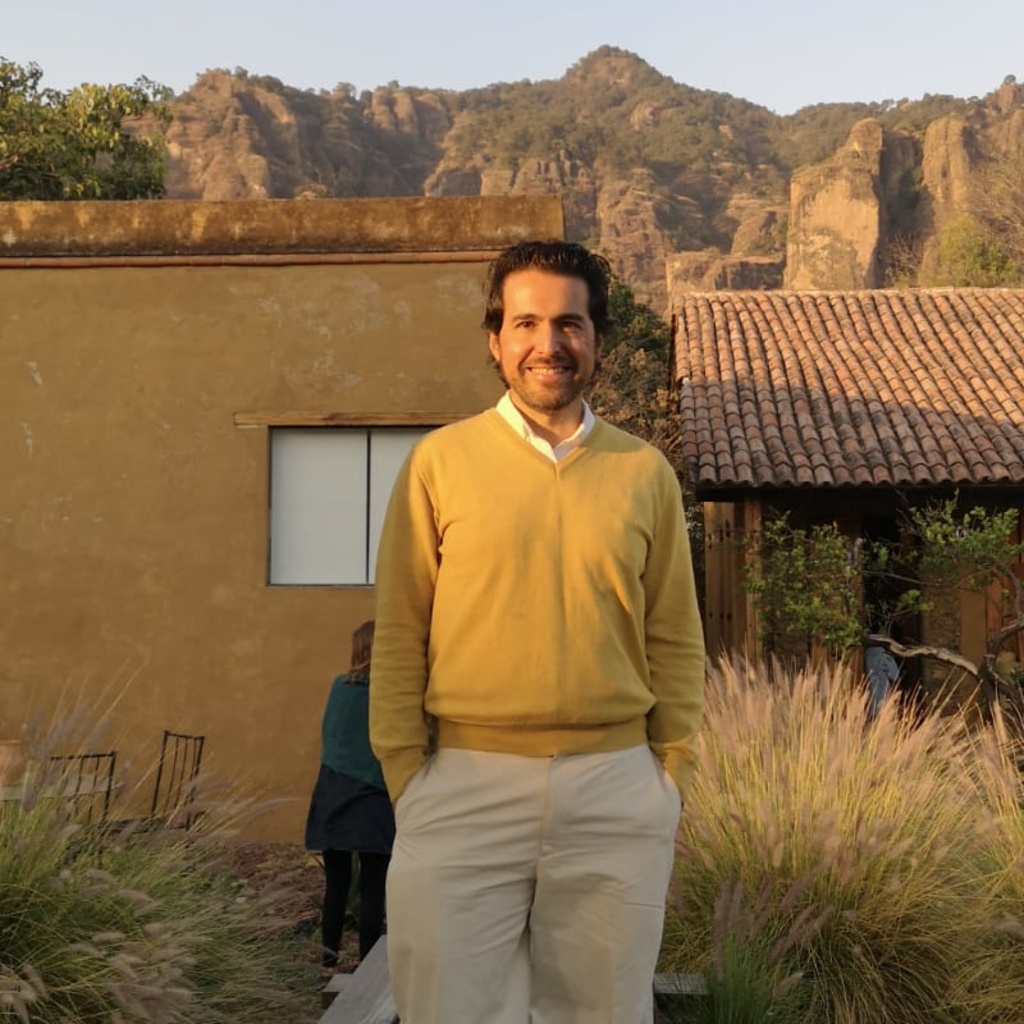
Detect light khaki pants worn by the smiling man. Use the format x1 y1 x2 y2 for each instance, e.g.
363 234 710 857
387 746 680 1024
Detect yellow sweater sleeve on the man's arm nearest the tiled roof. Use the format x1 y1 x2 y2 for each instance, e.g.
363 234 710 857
643 466 705 799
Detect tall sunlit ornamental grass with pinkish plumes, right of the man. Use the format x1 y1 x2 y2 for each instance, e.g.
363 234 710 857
662 660 1024 1024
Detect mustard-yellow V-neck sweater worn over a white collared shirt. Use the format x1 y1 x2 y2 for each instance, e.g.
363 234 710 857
370 410 705 800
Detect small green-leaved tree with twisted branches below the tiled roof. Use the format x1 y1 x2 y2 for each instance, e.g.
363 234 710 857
744 497 1024 712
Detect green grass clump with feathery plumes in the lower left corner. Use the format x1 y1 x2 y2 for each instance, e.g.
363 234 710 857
0 770 315 1024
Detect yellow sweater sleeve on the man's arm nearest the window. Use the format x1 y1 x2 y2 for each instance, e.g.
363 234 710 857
370 449 439 802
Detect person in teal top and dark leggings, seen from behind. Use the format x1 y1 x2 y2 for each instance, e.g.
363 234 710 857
306 620 394 969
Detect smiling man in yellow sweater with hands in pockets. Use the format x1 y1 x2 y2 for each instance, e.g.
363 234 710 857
370 242 705 1024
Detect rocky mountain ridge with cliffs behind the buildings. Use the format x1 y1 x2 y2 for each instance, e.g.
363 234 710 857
159 47 1024 308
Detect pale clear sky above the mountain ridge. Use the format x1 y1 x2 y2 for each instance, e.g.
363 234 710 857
0 0 1024 114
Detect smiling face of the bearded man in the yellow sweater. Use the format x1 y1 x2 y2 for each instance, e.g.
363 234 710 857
487 269 597 415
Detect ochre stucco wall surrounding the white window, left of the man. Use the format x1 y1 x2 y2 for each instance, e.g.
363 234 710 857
0 200 560 841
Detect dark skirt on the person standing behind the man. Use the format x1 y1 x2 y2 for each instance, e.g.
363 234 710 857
305 764 394 854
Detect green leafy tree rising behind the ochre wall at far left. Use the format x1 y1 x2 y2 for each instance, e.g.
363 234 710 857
0 57 170 200
